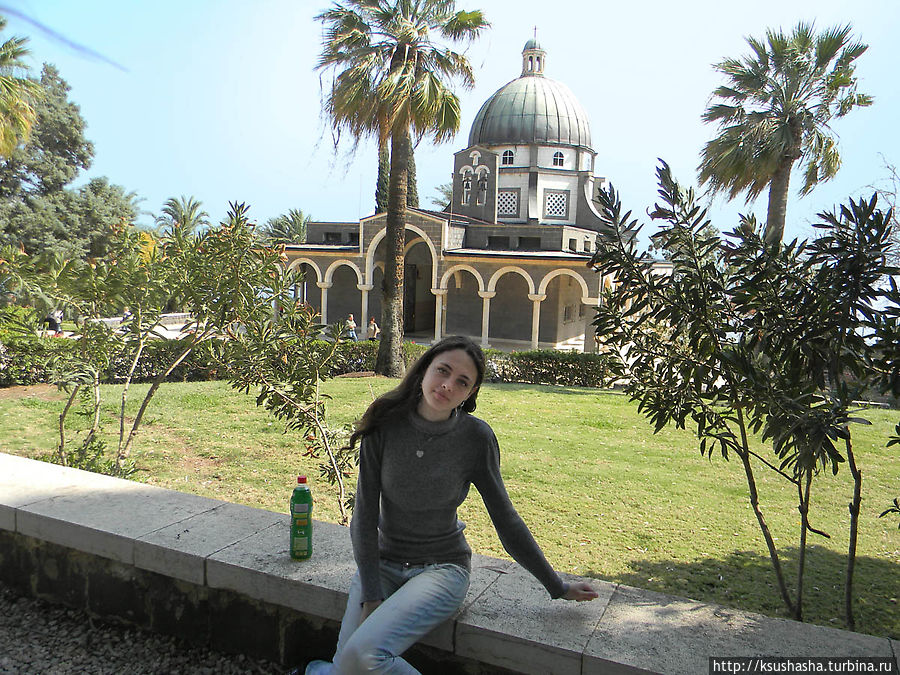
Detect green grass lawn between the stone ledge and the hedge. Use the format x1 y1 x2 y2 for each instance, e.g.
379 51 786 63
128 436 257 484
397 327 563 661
0 378 900 639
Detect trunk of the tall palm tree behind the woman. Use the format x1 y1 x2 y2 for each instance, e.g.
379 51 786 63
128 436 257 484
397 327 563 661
375 129 410 377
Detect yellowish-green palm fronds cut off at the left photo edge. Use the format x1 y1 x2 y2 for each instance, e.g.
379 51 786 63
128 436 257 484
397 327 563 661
0 16 42 157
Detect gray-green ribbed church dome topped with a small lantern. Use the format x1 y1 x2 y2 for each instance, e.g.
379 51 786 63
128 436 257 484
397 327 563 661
469 40 591 149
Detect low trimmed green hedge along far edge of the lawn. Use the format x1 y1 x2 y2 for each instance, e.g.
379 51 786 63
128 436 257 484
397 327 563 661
0 338 609 387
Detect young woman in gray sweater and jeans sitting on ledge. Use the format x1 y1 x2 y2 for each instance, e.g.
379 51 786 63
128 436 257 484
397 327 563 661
306 337 597 675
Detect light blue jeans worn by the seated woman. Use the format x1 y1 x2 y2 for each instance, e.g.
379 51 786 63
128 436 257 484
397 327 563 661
306 560 469 675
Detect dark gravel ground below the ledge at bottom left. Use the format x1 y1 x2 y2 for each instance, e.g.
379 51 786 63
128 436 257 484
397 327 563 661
0 585 285 675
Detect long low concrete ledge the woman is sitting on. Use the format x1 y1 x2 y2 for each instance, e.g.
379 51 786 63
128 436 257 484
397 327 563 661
0 454 900 675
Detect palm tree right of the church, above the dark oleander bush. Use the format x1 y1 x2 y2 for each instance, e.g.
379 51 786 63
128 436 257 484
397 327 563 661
699 23 872 245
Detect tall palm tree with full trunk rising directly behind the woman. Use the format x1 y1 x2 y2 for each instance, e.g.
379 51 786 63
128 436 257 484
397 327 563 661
317 0 489 377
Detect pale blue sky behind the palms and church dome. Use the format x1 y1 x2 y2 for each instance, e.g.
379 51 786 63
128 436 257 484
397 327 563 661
0 0 900 246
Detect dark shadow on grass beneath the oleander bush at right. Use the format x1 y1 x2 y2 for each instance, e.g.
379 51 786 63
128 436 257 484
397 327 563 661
586 546 900 640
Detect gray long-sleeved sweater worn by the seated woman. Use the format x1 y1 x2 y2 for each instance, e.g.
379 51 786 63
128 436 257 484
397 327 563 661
350 413 567 602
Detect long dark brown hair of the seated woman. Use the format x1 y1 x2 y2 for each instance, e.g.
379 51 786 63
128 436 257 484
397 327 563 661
350 335 484 448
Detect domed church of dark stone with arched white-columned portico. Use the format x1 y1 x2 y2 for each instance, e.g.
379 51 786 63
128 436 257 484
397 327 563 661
287 40 609 351
